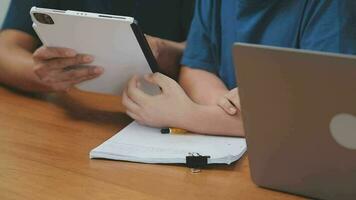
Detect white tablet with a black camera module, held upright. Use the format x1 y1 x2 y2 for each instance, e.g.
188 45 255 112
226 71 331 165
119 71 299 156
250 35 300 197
30 7 158 95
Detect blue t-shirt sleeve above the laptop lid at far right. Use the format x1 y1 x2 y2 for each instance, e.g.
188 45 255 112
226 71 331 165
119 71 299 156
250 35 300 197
300 0 356 54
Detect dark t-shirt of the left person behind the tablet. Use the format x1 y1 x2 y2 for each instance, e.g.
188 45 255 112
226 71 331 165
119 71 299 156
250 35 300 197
2 0 194 42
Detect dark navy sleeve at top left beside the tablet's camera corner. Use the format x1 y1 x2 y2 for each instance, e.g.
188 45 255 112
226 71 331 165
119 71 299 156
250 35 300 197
1 0 57 37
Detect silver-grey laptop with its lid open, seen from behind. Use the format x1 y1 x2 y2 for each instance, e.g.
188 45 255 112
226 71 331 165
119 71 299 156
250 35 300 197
233 43 356 199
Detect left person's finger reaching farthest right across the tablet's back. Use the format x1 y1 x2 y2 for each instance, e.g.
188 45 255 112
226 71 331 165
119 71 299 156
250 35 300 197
56 66 104 82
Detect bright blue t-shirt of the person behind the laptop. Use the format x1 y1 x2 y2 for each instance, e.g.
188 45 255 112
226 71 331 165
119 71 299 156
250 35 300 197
182 0 356 89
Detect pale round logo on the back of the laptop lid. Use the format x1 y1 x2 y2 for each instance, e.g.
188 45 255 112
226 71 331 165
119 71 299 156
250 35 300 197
330 113 356 150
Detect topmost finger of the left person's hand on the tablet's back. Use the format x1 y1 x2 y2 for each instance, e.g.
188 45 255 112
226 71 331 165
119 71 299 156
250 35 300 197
33 46 77 60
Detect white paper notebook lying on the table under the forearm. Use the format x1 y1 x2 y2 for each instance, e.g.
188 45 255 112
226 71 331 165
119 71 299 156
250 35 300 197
90 122 246 164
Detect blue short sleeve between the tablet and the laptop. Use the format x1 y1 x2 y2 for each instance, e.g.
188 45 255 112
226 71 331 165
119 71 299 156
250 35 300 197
181 0 219 74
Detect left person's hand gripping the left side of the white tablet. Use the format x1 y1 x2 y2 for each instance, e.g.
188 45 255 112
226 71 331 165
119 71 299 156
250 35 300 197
33 47 103 92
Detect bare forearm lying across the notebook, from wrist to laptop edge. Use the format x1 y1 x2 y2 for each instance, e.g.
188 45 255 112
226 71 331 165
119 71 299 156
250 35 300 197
175 105 244 137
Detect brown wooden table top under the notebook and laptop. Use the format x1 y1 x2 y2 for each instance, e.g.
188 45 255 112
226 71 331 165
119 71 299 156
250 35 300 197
0 86 301 200
